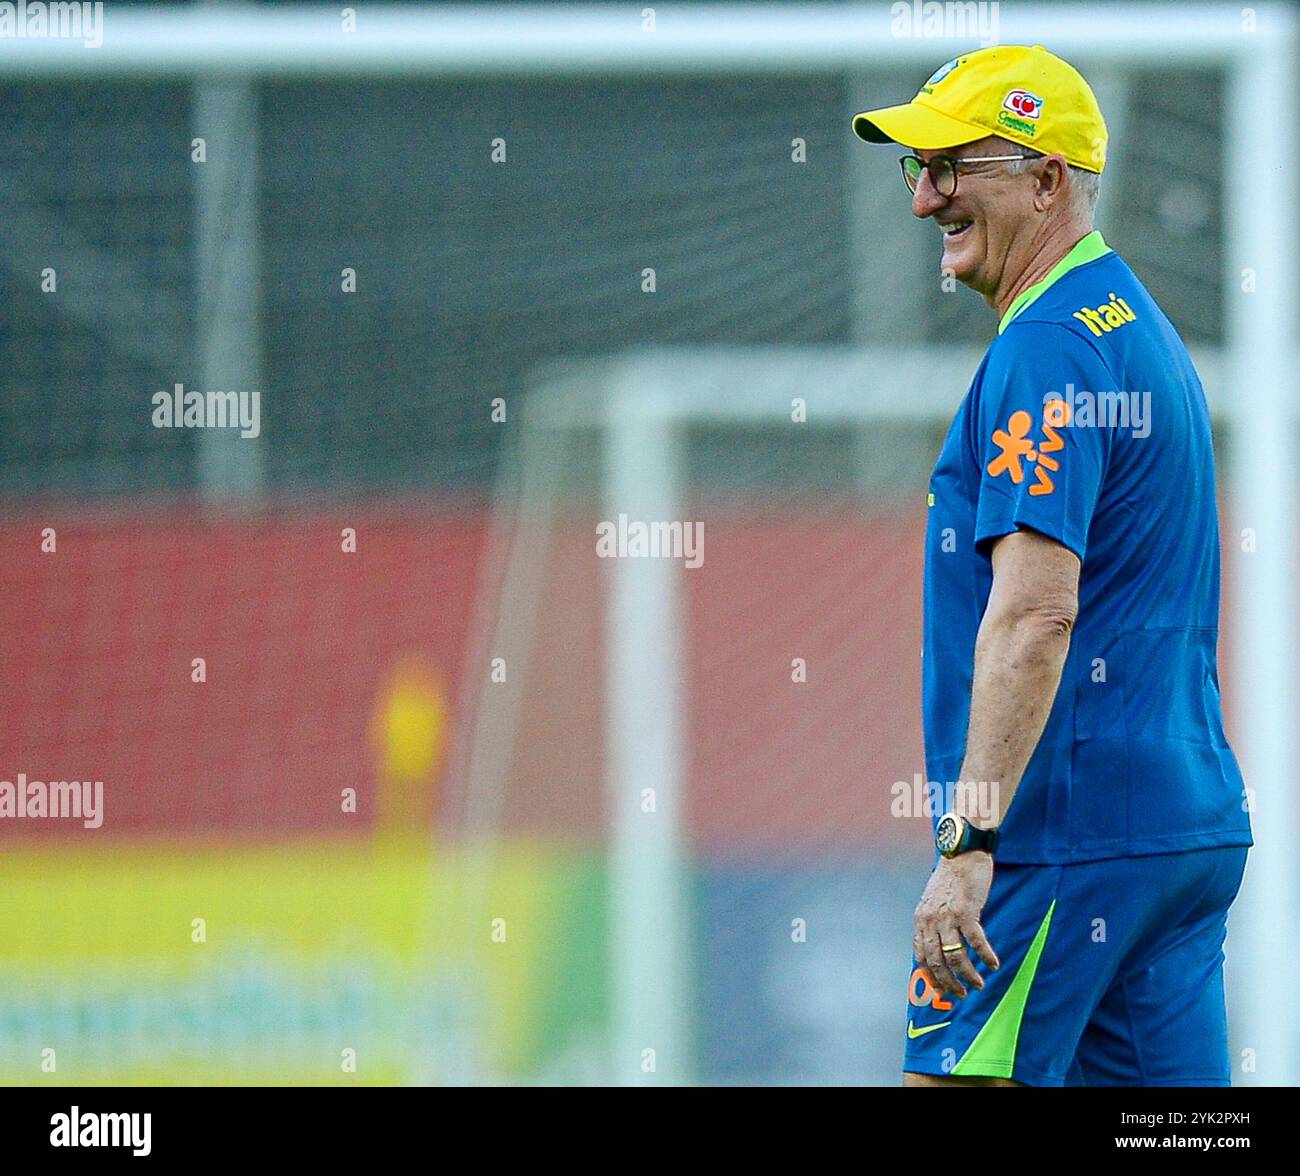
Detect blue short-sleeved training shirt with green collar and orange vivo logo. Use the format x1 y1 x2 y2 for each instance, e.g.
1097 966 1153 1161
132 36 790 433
923 233 1251 864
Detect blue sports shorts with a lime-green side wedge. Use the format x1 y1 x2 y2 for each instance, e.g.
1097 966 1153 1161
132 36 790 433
904 846 1247 1086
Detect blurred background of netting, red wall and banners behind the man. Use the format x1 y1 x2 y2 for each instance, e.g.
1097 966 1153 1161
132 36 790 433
0 0 1300 1084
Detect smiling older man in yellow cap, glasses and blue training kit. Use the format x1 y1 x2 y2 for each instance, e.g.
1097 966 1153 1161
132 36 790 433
853 45 1251 1085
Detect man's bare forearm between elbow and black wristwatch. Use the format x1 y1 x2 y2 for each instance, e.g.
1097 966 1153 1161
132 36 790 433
954 613 1073 828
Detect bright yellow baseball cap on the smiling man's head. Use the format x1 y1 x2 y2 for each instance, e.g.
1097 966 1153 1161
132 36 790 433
853 45 1108 173
